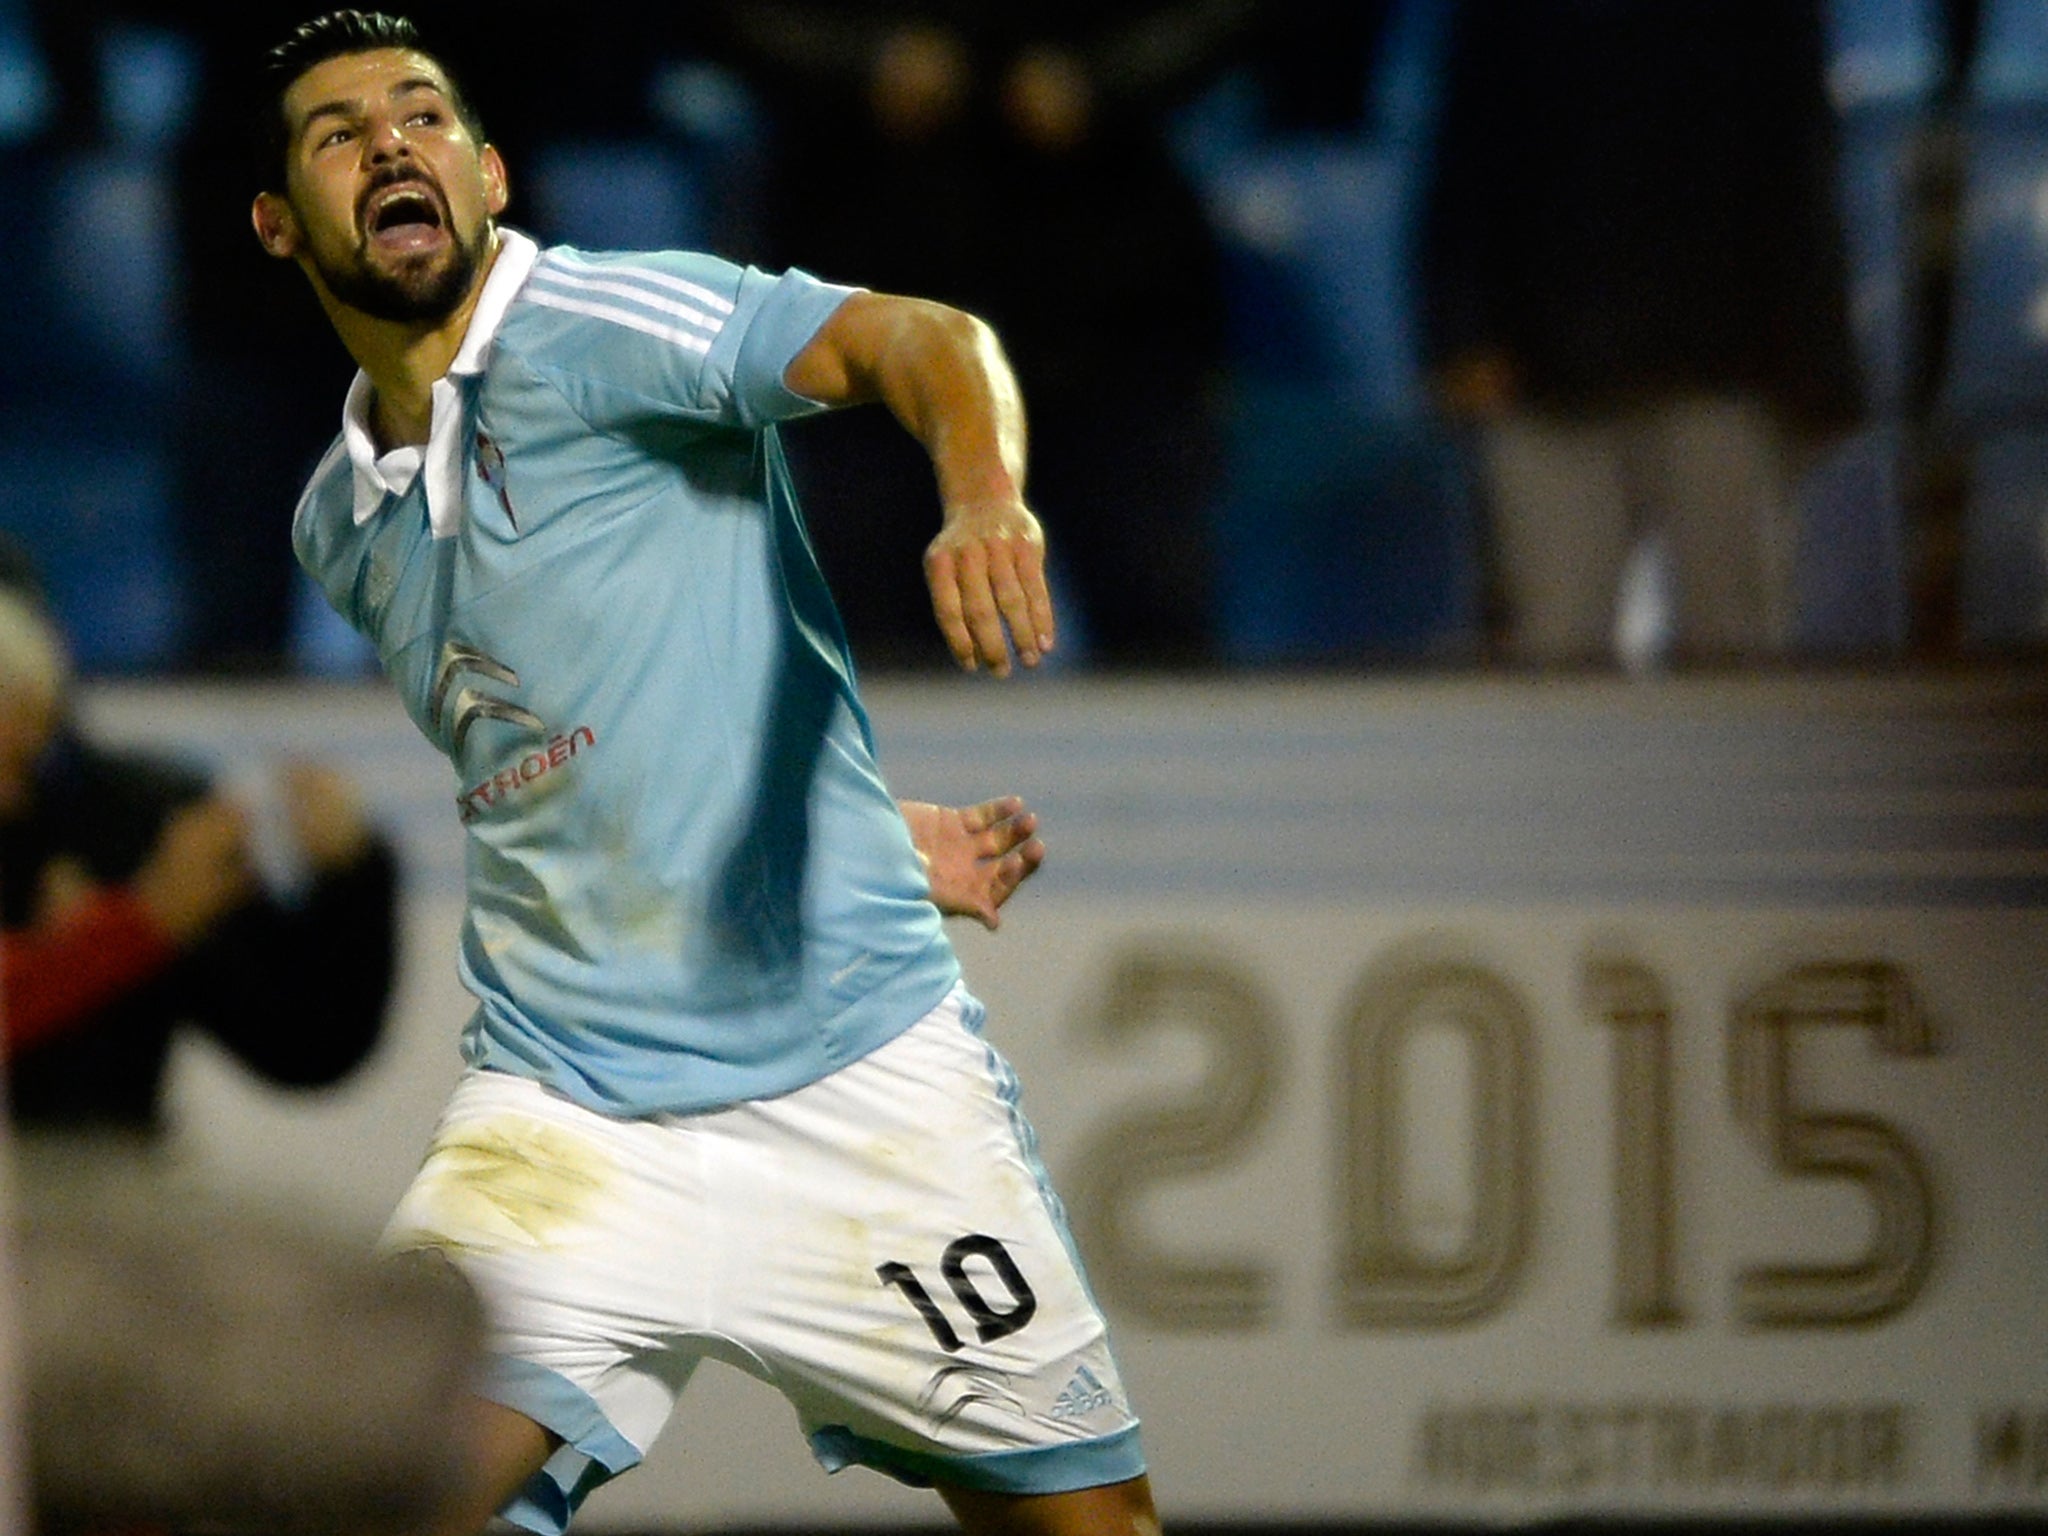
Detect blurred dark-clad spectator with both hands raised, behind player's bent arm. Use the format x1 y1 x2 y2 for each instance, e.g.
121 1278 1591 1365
707 0 1257 668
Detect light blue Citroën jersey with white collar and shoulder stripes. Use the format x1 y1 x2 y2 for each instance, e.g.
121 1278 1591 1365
293 231 958 1116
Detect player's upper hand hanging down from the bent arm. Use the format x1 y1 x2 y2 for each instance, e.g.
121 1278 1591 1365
924 502 1053 678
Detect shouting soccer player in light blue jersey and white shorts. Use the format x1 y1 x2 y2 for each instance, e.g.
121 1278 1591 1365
252 12 1157 1534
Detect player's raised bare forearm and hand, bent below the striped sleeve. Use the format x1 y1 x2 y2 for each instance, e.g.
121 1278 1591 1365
782 293 1053 678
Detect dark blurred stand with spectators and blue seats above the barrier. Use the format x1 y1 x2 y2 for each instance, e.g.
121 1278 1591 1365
0 0 2048 676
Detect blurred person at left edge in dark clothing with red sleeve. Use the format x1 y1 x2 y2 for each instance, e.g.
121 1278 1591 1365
0 536 397 1137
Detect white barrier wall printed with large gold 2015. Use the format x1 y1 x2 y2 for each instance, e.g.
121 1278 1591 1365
75 676 2048 1528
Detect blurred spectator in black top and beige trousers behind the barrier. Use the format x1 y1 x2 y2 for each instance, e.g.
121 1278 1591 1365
1421 0 1862 664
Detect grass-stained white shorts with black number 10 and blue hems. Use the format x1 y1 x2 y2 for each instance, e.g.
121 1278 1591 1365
383 989 1145 1532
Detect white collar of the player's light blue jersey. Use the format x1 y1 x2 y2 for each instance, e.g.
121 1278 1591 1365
342 225 541 539
